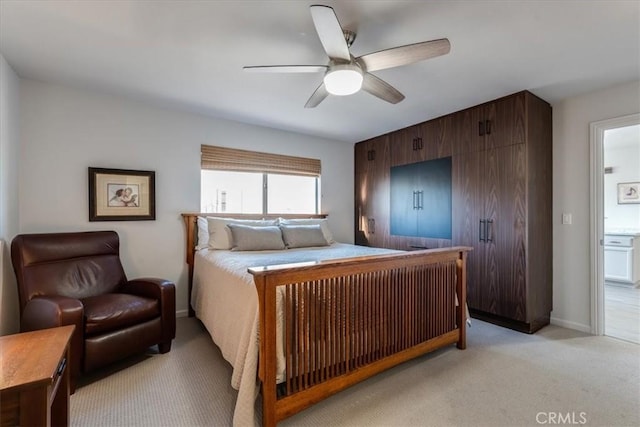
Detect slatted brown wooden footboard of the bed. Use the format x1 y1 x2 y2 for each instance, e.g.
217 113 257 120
249 247 470 426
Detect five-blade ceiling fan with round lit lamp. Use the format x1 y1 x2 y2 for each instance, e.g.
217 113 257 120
244 5 451 108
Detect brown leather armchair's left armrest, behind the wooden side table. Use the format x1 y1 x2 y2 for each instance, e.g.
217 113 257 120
20 296 84 386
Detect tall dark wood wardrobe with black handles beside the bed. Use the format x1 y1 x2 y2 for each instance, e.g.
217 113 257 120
355 91 552 333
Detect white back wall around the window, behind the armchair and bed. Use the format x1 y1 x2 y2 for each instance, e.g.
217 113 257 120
20 80 353 320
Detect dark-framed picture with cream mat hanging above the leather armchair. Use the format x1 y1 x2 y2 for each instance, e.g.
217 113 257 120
89 168 156 221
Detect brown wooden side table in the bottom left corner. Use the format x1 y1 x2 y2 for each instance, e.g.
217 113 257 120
0 325 75 427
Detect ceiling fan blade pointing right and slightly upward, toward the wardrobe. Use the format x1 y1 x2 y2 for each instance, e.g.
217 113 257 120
357 39 451 71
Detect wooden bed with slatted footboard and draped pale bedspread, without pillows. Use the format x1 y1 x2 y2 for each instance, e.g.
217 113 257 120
182 213 470 426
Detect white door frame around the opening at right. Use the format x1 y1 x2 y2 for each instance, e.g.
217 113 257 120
589 114 640 335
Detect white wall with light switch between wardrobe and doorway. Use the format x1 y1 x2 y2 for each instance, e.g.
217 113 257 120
551 81 640 332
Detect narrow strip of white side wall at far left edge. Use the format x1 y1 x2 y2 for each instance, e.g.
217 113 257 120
0 54 20 335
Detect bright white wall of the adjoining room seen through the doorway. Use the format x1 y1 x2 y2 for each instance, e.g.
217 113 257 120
604 130 640 231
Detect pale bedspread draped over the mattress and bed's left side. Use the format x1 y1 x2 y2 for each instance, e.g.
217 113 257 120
191 243 398 426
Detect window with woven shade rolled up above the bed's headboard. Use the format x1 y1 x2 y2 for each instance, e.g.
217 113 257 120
200 145 320 214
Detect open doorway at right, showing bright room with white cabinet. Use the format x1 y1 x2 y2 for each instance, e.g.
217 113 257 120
590 114 640 344
